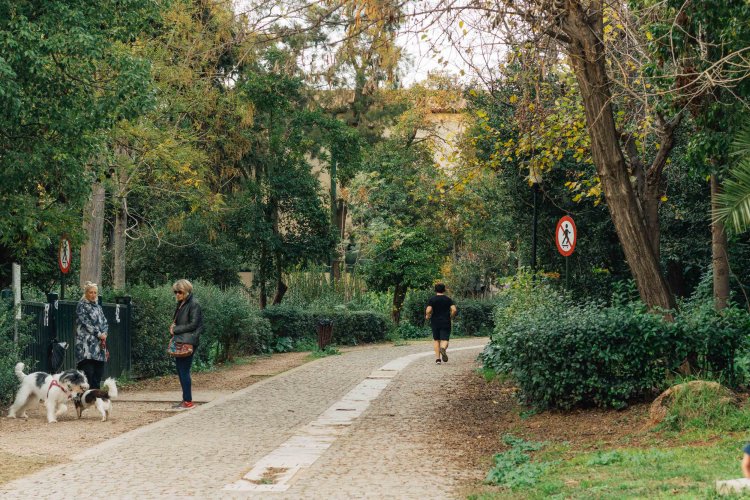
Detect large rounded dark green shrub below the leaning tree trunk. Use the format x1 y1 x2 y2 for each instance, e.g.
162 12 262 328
484 294 676 409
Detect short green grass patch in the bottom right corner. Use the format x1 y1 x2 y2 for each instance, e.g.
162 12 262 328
470 436 745 500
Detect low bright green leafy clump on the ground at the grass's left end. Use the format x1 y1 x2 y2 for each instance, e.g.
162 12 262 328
484 435 549 489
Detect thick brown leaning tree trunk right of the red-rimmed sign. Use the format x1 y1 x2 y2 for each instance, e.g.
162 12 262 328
562 2 675 309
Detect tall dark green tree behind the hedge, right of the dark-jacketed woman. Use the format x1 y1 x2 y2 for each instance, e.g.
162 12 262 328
228 68 335 295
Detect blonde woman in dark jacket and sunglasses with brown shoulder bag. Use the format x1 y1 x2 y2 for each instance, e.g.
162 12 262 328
169 280 203 410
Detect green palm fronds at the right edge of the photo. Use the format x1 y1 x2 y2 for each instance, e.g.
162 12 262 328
714 121 750 233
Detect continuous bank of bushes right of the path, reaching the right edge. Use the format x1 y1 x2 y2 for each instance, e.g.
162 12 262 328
482 278 750 408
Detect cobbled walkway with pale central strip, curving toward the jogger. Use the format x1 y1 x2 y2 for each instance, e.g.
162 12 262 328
0 339 486 499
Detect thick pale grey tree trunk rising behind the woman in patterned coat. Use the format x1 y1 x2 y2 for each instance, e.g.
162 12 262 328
80 182 106 288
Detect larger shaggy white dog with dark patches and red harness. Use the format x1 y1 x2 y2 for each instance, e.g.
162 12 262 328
8 363 89 423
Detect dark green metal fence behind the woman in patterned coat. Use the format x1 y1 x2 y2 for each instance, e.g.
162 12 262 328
21 294 132 377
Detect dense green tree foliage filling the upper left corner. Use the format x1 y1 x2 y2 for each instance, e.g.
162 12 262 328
0 0 157 281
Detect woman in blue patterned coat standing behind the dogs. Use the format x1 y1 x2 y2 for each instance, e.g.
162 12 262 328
76 281 109 389
